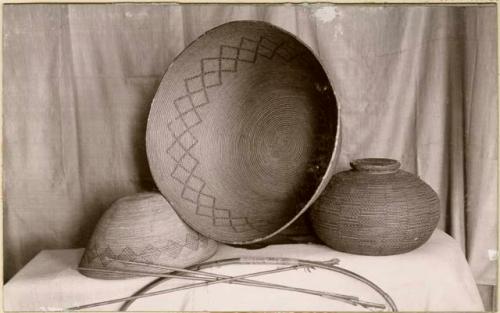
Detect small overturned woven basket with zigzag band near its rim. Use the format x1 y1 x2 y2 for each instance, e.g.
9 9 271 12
80 192 217 279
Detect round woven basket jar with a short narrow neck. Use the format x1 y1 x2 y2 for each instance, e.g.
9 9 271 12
310 159 440 255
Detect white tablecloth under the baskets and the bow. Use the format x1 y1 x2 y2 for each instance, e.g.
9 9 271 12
4 230 484 311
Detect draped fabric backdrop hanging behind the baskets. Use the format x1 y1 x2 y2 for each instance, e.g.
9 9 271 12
3 4 498 284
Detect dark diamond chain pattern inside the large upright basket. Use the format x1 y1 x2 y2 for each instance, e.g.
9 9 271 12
167 36 298 232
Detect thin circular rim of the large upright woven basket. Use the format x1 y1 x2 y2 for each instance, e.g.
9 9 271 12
146 20 341 245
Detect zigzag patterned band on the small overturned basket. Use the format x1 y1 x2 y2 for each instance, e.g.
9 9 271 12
84 233 208 267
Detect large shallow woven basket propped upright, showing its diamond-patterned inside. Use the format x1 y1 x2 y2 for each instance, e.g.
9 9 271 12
146 21 340 244
